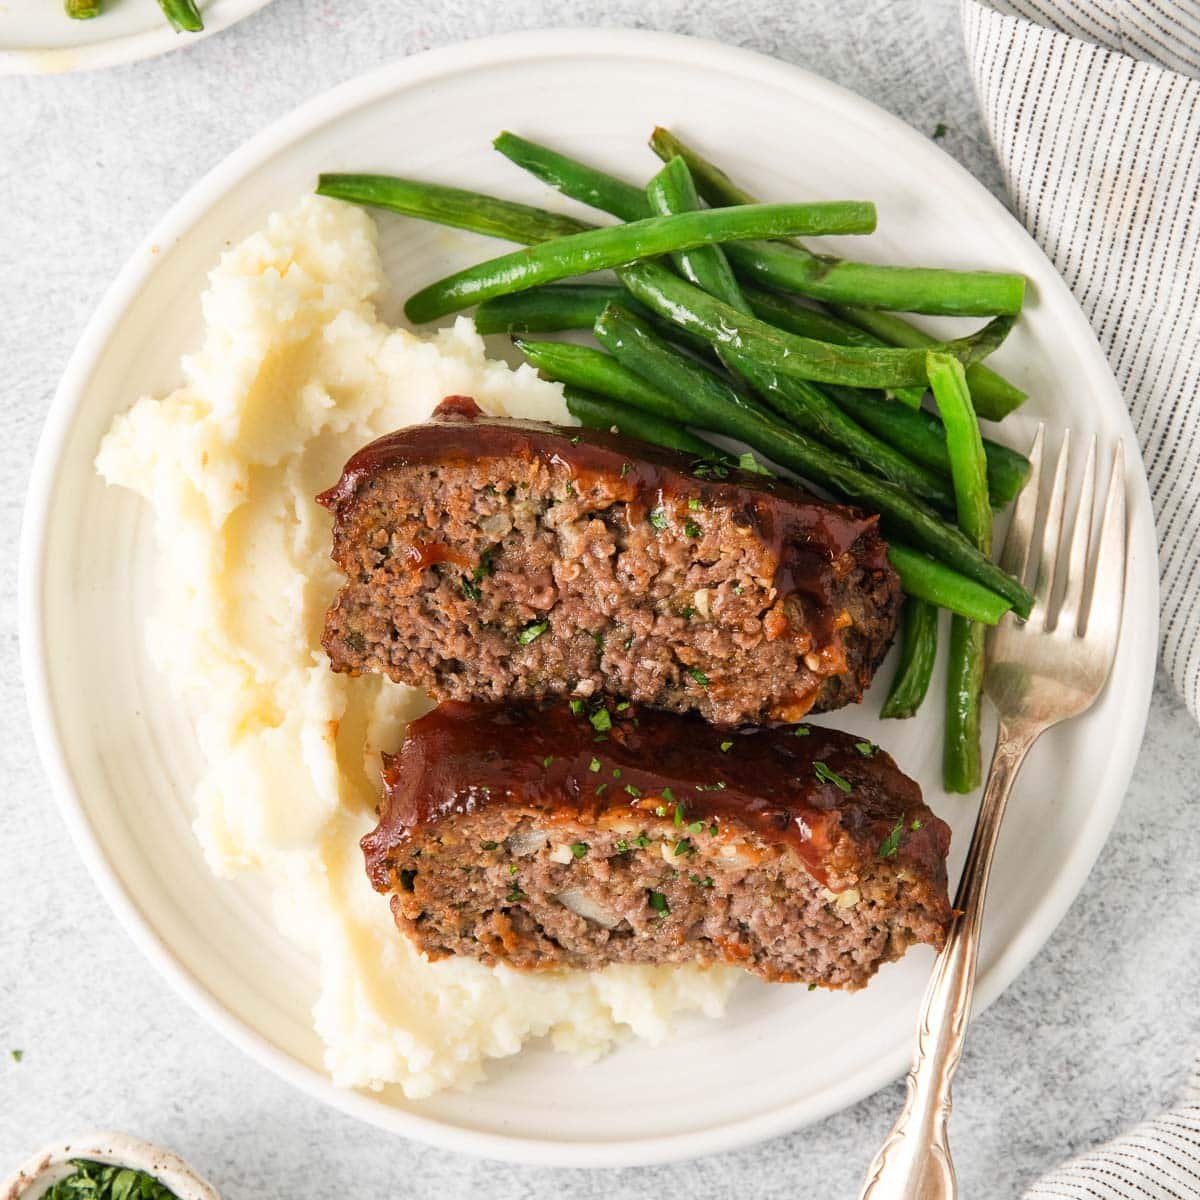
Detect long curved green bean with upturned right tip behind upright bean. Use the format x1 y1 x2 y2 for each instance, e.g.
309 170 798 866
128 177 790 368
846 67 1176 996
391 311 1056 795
617 260 1013 388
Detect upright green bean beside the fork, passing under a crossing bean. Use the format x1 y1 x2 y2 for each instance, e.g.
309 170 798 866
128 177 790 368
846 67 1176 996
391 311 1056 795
929 350 991 792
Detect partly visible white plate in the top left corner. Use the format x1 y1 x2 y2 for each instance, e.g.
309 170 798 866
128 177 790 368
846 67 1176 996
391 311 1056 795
0 0 270 76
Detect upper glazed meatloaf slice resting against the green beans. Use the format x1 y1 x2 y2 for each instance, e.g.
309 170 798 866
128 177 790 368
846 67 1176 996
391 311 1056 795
320 397 900 725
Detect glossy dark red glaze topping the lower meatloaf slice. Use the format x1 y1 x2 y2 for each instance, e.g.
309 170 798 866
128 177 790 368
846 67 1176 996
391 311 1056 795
362 701 949 890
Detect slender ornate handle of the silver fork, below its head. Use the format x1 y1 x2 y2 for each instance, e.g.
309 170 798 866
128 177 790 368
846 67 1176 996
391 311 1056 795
859 724 1042 1200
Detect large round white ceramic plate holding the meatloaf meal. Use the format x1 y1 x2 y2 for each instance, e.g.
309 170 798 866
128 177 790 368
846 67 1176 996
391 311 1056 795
22 31 1157 1165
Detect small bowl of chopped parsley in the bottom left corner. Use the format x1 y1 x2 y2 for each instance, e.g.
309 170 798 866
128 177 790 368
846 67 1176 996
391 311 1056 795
0 1133 221 1200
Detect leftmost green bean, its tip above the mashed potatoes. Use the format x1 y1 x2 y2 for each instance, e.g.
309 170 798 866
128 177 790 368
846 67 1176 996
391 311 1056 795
317 174 595 245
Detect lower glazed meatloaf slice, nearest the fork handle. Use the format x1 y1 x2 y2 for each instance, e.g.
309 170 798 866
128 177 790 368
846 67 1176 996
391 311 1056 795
362 701 950 989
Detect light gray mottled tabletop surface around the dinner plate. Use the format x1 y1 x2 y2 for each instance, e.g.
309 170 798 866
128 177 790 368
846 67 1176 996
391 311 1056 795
0 0 1200 1200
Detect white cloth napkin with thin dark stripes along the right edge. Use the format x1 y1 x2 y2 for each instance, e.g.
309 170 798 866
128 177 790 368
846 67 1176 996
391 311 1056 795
961 0 1200 1200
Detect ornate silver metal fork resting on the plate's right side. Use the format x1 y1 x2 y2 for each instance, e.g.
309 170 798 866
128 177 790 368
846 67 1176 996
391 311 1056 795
860 427 1126 1200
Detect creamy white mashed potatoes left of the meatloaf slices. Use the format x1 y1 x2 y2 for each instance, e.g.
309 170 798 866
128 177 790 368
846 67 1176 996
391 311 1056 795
96 197 736 1097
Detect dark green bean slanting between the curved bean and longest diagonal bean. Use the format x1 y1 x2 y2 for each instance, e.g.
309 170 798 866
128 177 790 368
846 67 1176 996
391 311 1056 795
710 350 954 512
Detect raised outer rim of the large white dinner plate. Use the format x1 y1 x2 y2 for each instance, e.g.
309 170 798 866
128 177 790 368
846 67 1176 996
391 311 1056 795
18 30 1158 1168
